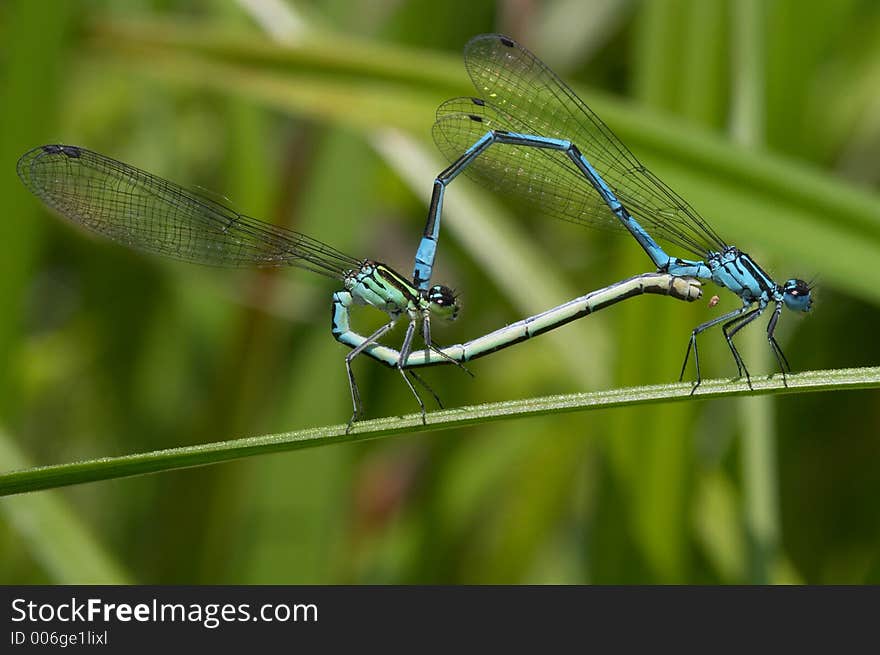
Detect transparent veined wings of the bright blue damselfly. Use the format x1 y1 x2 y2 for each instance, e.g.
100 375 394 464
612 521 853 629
434 34 724 257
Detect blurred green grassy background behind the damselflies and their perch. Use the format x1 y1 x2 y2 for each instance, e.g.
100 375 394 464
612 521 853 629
0 0 880 583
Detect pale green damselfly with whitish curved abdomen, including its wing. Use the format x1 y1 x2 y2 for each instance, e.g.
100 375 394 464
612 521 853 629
18 145 701 428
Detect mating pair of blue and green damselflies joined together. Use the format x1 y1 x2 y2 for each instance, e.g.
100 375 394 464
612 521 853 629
18 34 811 427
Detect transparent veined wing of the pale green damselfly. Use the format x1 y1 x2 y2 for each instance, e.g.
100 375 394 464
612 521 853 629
18 145 360 279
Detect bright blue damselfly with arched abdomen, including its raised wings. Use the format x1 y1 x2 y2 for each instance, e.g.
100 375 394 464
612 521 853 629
413 34 812 393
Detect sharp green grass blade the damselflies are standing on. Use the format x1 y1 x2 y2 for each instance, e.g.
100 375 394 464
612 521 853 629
0 367 880 496
